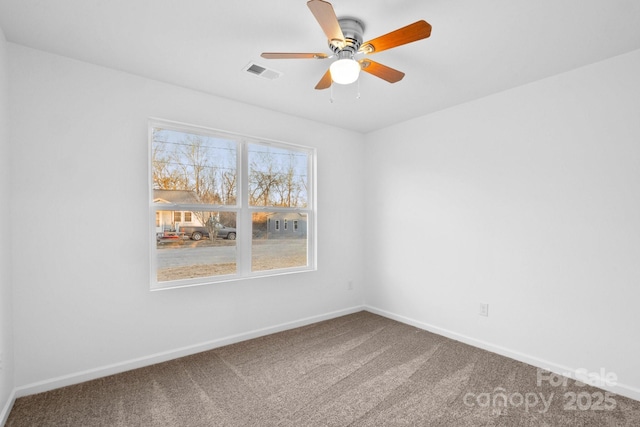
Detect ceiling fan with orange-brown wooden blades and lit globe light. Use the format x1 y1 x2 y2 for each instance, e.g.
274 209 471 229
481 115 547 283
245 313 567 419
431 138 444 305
261 0 431 89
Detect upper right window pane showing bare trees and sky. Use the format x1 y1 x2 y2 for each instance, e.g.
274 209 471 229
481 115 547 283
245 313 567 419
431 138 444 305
248 144 309 207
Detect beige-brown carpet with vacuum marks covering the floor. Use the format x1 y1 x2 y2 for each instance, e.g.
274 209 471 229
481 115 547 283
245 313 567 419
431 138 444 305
7 312 640 427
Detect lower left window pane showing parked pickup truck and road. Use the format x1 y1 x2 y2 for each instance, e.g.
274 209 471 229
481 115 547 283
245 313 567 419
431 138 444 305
156 211 237 282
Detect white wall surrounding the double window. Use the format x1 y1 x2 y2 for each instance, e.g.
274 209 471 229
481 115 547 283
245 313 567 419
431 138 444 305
9 44 364 395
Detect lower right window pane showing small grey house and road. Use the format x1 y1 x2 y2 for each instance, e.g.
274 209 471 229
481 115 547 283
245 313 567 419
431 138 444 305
251 212 307 271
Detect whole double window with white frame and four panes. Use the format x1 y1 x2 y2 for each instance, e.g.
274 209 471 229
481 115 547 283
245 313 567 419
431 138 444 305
149 120 315 289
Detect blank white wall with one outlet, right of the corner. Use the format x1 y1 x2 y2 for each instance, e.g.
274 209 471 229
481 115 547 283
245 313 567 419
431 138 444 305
365 51 640 399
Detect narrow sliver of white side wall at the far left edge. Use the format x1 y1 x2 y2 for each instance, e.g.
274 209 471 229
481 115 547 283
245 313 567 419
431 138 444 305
0 22 13 425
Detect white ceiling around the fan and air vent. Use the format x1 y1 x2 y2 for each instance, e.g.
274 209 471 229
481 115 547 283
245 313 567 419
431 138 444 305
0 0 640 133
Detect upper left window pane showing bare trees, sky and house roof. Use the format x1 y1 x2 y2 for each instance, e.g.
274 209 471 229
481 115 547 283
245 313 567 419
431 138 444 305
151 128 237 205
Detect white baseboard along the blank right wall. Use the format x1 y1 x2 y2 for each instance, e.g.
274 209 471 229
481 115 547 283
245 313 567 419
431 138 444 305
364 305 640 401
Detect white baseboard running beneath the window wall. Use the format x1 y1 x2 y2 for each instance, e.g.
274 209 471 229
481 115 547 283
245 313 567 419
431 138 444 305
13 306 365 402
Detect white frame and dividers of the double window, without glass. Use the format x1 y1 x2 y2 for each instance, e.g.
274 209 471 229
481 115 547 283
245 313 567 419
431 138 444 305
147 118 317 291
